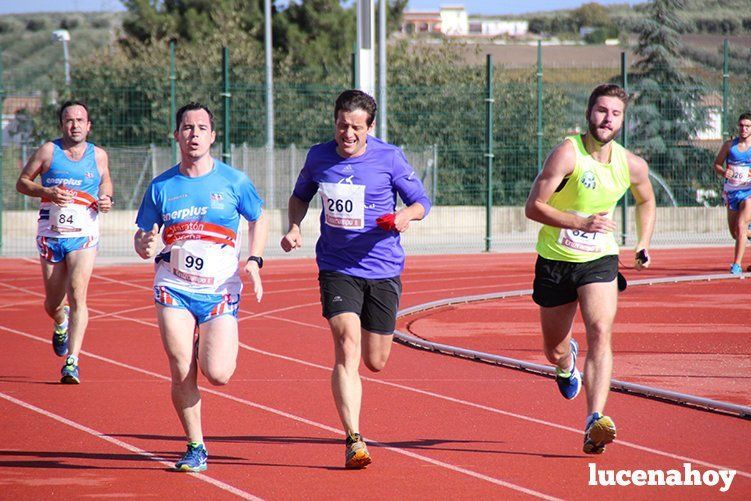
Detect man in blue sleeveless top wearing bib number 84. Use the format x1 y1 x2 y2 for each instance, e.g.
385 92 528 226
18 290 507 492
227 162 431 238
16 101 114 384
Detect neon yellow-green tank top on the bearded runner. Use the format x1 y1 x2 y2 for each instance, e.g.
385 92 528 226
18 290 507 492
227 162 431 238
537 135 631 263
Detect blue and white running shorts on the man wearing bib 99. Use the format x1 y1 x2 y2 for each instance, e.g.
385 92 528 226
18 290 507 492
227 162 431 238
154 285 240 325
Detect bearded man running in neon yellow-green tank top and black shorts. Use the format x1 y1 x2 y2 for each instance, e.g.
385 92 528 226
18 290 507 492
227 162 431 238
525 84 655 454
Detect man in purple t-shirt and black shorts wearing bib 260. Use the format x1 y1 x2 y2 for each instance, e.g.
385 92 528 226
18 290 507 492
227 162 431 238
281 90 430 469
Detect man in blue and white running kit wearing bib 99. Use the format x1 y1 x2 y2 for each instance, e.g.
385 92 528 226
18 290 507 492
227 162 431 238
133 102 268 472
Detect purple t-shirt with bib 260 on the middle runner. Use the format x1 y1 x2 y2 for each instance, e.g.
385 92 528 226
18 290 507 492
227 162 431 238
292 136 431 279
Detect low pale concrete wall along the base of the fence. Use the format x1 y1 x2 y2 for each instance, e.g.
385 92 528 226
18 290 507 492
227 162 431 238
2 206 732 259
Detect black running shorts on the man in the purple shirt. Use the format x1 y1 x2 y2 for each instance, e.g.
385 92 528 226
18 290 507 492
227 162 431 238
318 271 402 335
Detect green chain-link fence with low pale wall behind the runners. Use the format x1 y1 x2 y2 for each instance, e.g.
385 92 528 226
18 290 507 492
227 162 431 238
0 40 751 257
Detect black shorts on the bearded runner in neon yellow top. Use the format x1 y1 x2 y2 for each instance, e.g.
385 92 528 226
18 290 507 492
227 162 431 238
532 256 618 308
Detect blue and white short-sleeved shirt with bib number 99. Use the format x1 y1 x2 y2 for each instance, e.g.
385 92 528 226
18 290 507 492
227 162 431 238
136 160 263 294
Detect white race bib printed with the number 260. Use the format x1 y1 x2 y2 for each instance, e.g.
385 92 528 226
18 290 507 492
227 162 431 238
318 183 365 230
